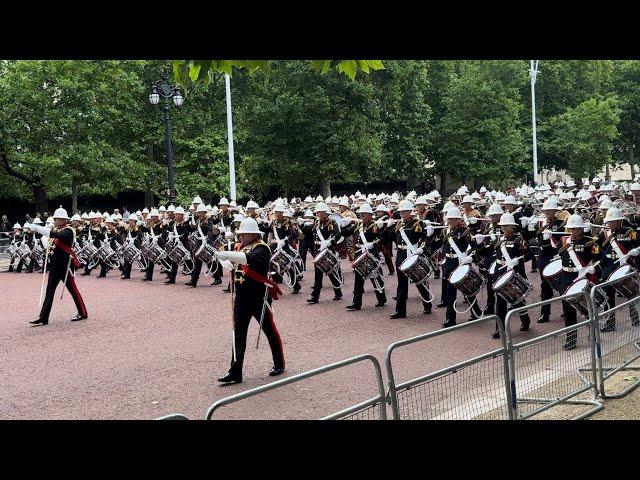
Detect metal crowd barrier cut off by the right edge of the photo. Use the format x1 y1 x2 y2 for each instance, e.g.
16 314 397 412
590 272 640 398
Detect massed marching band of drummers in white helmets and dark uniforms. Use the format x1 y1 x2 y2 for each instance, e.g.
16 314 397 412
9 179 640 354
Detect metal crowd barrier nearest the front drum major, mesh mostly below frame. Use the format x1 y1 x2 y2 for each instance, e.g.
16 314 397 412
205 354 387 420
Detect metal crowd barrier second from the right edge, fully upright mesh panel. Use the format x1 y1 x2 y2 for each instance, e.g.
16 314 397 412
505 292 604 420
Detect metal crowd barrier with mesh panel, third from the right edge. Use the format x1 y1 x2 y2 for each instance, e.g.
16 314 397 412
386 315 512 420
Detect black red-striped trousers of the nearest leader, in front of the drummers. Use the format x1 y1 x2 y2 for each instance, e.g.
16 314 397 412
229 296 285 377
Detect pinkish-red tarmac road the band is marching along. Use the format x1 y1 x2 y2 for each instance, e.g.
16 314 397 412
0 260 563 419
